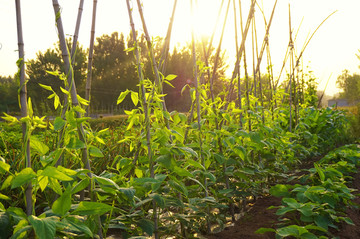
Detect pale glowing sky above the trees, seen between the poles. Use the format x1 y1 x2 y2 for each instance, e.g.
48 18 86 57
0 0 360 95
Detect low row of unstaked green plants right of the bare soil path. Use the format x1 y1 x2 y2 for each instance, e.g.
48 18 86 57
264 145 360 238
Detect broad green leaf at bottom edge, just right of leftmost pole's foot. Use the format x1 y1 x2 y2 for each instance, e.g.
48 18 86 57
28 215 56 239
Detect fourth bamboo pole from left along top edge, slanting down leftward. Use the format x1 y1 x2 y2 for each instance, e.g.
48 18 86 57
85 0 97 116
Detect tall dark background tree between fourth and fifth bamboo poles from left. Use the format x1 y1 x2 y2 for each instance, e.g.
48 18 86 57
91 32 137 111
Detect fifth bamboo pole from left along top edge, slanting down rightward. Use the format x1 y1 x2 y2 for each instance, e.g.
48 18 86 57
126 0 159 239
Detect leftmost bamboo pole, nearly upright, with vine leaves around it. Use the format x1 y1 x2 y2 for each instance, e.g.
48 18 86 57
15 0 33 216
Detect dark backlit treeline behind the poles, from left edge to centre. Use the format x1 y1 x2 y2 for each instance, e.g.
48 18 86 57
0 32 226 115
